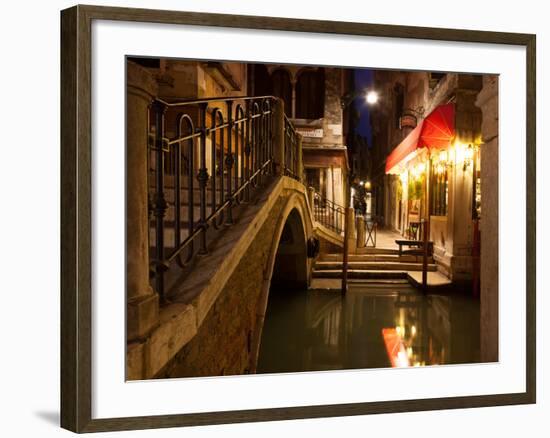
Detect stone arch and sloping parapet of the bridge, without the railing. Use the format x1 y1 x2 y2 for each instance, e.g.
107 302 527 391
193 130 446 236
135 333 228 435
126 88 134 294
127 176 339 380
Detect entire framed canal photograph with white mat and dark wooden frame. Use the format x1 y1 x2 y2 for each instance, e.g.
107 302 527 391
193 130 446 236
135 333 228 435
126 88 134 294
61 6 536 432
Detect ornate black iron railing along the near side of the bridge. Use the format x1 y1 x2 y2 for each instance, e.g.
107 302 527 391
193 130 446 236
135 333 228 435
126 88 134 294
148 96 282 300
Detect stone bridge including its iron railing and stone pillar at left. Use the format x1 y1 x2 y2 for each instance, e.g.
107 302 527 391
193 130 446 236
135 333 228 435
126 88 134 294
126 63 350 380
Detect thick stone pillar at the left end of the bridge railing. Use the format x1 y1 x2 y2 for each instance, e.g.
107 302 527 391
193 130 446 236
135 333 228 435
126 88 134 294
126 62 159 341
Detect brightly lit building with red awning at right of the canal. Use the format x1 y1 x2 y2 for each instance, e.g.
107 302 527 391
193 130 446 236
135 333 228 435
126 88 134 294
371 71 498 281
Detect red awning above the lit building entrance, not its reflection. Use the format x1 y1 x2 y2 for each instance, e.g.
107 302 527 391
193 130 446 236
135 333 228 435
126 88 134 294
386 103 455 173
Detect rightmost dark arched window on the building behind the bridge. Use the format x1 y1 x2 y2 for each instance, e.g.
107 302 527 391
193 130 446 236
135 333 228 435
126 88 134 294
296 68 325 119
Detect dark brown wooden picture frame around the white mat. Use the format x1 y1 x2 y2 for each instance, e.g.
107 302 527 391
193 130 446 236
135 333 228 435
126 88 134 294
61 6 536 432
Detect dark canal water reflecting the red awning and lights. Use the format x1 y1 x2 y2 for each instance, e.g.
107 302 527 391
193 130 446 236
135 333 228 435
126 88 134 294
257 283 480 373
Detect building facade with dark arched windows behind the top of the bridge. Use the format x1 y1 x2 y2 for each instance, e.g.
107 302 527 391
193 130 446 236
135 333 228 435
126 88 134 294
249 64 351 210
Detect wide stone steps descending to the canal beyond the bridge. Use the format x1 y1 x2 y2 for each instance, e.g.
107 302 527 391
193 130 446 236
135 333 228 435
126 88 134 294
313 248 437 281
